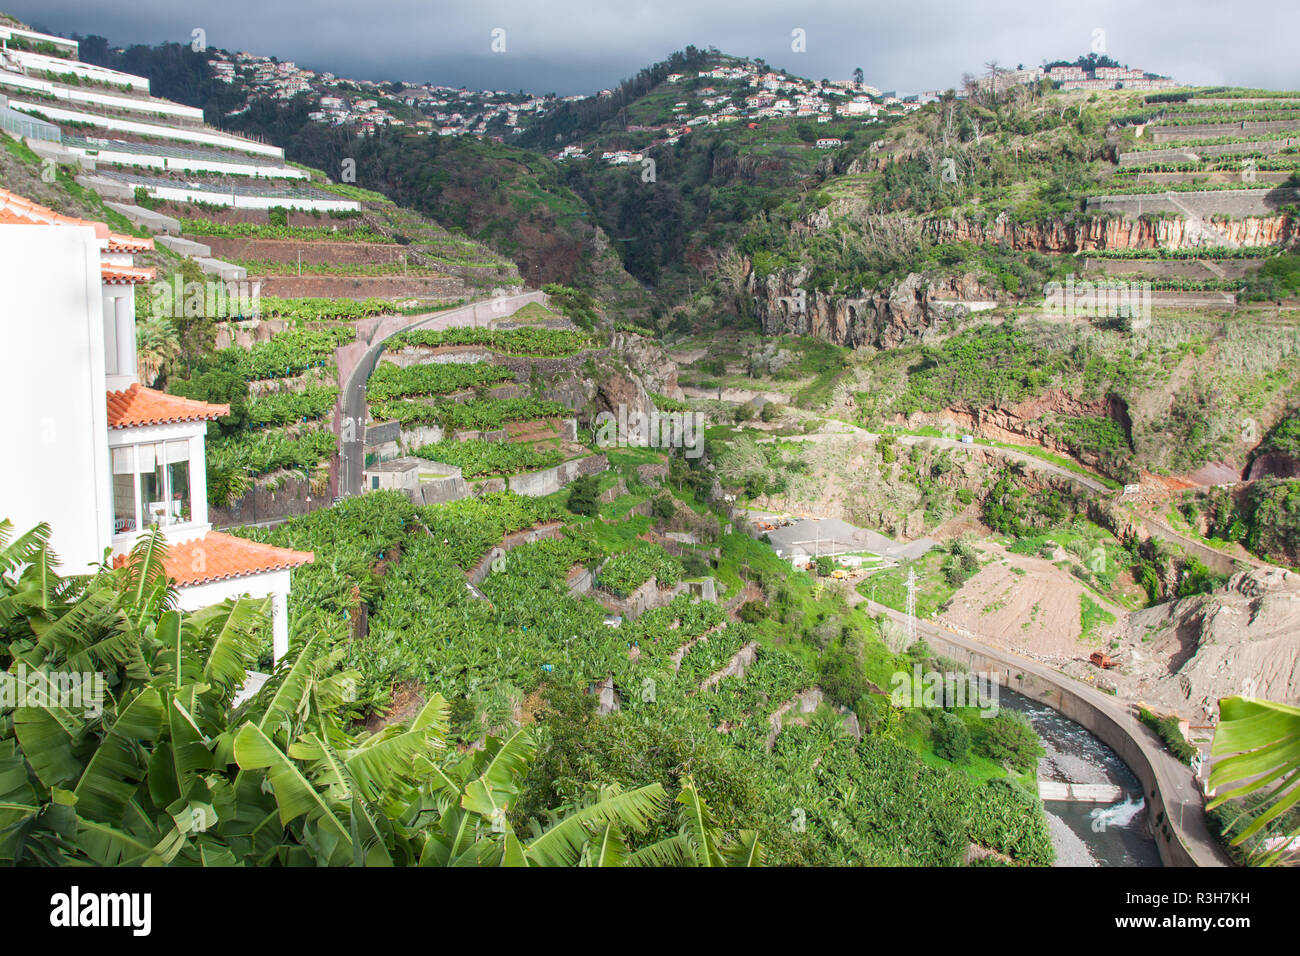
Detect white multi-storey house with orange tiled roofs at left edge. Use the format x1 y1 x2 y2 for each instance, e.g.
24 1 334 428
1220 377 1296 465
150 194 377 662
0 189 313 659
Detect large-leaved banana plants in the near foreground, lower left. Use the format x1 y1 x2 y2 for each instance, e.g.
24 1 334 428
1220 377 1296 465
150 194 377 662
0 523 761 866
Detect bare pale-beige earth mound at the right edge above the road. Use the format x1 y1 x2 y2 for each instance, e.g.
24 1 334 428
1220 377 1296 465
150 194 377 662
1119 567 1300 723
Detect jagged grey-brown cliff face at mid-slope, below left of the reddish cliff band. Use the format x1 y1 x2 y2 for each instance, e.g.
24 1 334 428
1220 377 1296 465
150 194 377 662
749 269 997 349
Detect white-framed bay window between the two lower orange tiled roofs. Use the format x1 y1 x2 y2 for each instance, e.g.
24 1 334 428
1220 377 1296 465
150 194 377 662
113 438 192 535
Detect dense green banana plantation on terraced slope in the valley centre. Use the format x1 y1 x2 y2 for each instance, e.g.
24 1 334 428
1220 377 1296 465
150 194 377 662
239 492 1052 865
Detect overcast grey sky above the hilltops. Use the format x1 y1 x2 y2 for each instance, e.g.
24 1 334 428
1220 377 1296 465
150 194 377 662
5 0 1300 95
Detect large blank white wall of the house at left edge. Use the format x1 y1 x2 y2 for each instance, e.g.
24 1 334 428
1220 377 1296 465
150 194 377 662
0 225 112 574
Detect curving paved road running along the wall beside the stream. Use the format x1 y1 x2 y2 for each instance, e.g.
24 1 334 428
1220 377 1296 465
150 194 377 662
859 598 1232 866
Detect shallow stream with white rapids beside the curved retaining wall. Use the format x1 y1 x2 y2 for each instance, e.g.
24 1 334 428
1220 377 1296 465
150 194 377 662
1000 687 1161 866
